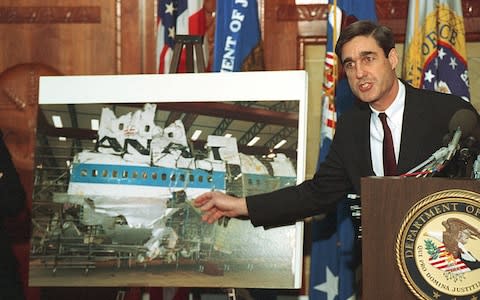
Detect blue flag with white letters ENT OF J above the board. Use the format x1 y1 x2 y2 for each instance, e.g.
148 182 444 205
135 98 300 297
213 0 261 72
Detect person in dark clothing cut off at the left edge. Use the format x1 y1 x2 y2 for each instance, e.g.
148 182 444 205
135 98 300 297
0 132 25 300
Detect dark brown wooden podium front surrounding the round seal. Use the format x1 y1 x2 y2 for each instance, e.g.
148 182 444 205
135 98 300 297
361 177 480 300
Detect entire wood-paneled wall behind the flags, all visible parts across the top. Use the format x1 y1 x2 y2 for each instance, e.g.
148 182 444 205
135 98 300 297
0 0 480 75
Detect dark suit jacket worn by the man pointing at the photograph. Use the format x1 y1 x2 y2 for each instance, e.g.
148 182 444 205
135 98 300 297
247 83 478 226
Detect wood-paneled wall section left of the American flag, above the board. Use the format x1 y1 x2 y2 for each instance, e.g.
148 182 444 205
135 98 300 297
0 0 156 75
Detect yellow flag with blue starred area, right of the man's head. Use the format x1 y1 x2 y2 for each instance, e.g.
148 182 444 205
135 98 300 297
402 0 470 101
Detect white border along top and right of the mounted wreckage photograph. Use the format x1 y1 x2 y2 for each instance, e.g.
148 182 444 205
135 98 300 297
39 70 308 288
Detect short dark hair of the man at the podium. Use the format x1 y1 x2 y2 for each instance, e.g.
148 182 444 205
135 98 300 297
335 20 395 63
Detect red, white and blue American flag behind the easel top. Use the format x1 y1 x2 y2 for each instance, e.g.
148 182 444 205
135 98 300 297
157 0 206 73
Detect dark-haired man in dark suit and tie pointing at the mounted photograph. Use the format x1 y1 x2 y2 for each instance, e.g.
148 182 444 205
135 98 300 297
194 21 478 226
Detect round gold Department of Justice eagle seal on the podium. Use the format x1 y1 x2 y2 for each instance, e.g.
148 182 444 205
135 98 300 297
395 190 480 300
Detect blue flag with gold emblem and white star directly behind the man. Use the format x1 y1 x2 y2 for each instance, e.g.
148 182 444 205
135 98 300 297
309 0 377 300
